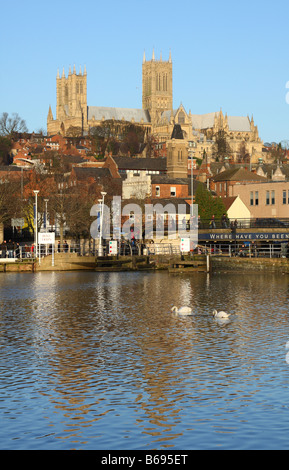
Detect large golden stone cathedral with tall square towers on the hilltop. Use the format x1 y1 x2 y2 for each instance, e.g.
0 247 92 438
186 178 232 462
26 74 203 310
47 51 263 162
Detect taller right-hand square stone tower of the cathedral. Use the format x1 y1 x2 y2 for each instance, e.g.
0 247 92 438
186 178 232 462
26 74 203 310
142 51 173 126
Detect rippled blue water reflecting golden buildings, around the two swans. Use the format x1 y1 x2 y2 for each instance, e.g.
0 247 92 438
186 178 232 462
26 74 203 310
0 272 289 450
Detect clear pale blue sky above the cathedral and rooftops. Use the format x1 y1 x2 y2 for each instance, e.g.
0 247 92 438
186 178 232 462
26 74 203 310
0 0 289 142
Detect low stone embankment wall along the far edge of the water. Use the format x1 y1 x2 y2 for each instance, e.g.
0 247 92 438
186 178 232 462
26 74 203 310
0 253 289 274
